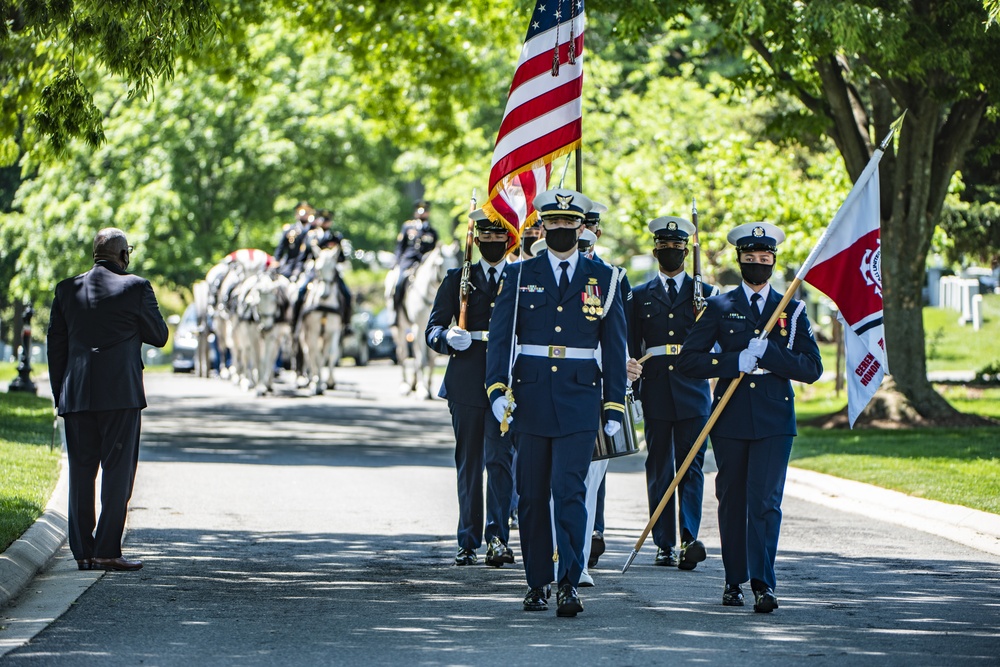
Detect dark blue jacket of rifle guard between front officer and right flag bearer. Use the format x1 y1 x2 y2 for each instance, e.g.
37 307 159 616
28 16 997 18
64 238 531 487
629 275 718 421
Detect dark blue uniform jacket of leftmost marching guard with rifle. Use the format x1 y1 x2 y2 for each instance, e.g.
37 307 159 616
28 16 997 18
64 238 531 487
424 262 503 408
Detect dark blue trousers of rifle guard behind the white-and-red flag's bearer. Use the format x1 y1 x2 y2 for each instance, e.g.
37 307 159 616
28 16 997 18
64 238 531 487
646 416 708 549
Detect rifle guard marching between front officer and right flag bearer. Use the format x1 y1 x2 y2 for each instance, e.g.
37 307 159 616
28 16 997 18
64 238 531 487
629 216 719 570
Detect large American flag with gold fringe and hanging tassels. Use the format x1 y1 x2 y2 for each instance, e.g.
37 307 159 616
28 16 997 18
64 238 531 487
483 0 584 248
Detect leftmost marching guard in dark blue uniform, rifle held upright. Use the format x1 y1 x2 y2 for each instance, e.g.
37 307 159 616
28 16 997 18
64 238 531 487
425 209 514 567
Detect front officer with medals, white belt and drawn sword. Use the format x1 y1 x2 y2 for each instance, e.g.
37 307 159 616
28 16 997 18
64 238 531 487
486 188 626 616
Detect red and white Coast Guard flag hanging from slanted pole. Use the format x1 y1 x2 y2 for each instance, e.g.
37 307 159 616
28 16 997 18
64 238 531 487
798 145 892 428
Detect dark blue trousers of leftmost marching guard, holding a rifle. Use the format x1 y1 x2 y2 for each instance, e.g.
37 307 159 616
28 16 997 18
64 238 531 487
448 401 514 550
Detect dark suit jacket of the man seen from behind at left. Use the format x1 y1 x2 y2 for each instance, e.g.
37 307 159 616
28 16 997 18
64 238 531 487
48 261 167 415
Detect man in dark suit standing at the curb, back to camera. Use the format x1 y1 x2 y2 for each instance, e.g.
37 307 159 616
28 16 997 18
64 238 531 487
48 228 167 570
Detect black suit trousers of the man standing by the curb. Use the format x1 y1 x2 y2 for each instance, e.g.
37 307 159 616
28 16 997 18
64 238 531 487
64 408 141 560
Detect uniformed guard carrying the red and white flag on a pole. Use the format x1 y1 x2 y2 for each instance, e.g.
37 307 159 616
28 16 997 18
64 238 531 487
680 222 823 612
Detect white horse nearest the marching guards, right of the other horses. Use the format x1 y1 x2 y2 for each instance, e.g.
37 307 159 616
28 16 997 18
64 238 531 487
385 243 461 399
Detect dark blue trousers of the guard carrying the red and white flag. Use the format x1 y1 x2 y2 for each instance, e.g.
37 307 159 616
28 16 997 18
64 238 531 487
712 435 793 588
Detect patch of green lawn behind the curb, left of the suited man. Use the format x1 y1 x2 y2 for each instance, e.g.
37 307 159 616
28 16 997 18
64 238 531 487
0 392 60 551
